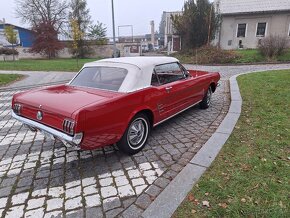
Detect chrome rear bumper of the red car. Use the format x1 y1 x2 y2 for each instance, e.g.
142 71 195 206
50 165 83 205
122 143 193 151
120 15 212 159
12 110 73 143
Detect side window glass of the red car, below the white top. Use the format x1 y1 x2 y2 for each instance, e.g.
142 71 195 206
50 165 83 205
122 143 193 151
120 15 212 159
151 63 185 86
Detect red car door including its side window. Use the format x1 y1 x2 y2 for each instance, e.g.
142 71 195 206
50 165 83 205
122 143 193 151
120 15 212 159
152 62 192 120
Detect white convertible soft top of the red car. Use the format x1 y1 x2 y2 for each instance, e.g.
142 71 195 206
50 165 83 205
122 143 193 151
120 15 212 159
84 57 179 92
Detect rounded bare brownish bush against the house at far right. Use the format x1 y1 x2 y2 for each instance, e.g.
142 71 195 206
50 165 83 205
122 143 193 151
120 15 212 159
258 35 288 59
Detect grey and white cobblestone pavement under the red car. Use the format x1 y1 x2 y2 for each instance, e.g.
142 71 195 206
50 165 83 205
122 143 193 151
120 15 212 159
0 62 290 218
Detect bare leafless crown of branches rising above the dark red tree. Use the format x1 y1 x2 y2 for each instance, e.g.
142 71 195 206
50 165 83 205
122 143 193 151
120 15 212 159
16 0 68 32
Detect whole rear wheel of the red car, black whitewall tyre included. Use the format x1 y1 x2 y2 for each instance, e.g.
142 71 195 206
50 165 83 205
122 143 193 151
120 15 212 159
117 113 150 155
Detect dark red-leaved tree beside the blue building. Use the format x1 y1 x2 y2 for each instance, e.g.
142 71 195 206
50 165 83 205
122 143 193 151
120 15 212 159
30 23 64 59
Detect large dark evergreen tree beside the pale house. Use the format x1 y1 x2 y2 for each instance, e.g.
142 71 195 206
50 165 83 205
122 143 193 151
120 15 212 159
172 0 219 50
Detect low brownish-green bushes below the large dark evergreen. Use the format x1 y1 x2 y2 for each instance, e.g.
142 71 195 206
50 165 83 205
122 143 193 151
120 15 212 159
173 46 241 64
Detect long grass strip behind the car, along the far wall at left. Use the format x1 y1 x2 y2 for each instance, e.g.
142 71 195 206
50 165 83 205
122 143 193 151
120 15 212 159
0 59 97 72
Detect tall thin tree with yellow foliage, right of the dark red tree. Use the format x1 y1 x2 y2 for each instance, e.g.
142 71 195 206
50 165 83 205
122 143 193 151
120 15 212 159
69 0 92 58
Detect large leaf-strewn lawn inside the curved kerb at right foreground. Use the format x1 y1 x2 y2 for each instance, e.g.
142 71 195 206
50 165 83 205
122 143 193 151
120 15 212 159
173 70 290 217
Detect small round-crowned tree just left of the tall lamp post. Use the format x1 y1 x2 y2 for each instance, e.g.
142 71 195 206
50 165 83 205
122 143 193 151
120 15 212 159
88 22 107 45
